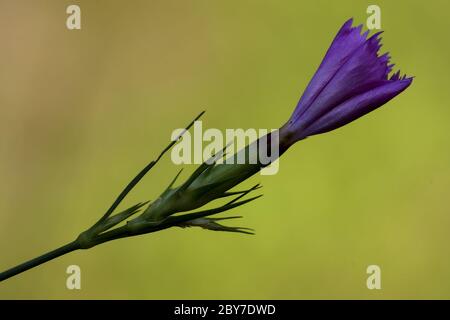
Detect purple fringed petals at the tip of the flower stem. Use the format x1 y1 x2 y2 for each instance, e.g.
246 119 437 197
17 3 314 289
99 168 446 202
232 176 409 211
280 19 412 147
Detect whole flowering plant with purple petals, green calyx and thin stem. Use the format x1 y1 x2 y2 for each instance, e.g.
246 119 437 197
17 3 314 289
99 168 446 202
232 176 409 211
0 19 412 281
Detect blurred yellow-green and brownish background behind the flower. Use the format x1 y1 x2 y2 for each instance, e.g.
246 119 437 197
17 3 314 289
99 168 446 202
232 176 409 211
0 0 450 299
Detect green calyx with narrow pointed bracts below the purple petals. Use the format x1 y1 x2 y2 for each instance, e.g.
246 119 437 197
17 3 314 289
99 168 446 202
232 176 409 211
76 112 262 249
